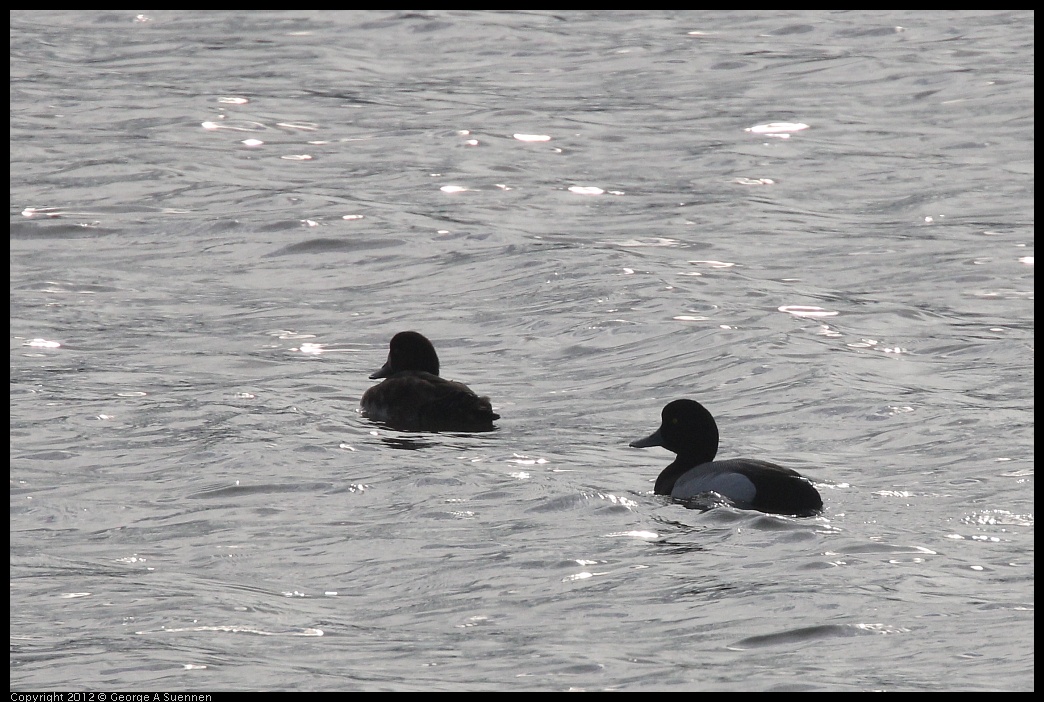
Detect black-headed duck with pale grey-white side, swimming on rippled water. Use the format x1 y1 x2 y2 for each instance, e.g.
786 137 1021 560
631 399 823 517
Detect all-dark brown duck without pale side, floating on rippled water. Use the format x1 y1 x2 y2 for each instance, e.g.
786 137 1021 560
360 331 500 431
